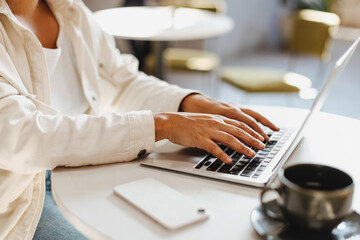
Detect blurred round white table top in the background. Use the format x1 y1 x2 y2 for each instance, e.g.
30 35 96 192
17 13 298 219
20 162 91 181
95 6 234 41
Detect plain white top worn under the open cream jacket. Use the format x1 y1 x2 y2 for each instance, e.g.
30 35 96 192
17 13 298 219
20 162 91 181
43 29 90 116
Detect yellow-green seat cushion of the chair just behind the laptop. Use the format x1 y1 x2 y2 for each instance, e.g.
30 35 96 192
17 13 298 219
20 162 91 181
221 67 311 92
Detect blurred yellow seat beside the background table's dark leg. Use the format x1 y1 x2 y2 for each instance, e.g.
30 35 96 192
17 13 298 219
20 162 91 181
164 48 219 72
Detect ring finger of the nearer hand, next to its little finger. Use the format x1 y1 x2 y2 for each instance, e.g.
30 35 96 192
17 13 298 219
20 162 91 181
212 131 256 158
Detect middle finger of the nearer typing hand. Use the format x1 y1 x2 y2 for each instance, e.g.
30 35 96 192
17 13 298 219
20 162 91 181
215 124 265 149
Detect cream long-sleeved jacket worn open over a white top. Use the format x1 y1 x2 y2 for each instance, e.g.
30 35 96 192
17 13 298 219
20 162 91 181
0 0 192 240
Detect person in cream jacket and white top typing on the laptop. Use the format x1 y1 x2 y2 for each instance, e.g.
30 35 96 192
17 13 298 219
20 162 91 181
0 0 278 239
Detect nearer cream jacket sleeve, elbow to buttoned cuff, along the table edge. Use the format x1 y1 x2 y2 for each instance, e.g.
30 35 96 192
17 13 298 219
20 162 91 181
0 74 155 174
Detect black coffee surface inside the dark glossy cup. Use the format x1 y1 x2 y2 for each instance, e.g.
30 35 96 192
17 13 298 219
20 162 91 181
284 164 353 191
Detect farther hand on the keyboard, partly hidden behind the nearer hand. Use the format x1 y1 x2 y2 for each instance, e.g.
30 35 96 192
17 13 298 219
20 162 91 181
179 94 279 140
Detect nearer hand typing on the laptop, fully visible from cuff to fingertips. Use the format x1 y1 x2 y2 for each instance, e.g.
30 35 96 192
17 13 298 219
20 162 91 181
154 112 265 163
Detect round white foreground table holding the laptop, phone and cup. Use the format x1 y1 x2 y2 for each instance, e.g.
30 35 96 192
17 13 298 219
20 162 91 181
52 107 360 240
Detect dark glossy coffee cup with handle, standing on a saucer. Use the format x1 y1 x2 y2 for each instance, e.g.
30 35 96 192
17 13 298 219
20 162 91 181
261 164 354 231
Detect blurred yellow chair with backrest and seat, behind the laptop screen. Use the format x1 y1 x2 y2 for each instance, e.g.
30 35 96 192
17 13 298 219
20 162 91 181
220 10 340 95
